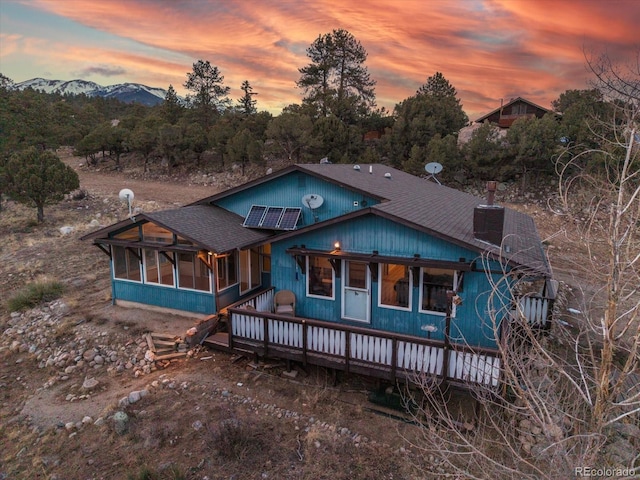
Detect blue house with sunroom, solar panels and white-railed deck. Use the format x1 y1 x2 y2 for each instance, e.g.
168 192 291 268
83 163 551 386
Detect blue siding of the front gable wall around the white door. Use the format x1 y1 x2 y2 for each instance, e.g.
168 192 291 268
271 215 495 347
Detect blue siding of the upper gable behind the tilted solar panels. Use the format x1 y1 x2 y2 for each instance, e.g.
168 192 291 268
216 172 379 227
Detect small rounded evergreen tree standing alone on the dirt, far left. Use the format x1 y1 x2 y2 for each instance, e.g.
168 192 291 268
4 147 80 222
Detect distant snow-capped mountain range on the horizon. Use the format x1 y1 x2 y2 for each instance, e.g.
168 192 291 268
14 78 167 106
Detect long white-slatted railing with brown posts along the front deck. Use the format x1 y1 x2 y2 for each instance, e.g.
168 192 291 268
229 306 500 387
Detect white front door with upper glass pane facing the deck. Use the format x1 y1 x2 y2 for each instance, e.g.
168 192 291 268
342 261 371 323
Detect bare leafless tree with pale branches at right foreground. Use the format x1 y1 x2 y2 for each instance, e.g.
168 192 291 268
407 56 640 479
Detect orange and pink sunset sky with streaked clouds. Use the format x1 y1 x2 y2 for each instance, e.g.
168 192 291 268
0 0 640 120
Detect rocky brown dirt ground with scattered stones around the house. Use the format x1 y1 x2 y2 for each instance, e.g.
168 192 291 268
0 151 639 480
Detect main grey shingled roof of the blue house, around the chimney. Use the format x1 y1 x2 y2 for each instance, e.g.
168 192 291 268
216 164 550 276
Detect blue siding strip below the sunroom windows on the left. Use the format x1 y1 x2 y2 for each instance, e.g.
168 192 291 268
113 280 216 314
